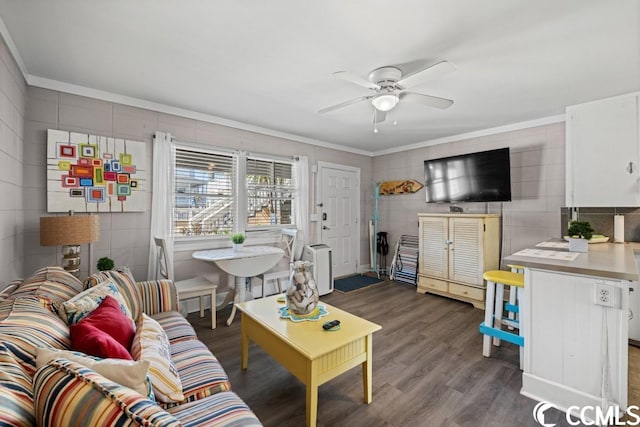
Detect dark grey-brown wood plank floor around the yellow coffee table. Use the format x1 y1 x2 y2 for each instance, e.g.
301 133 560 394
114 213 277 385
188 282 567 427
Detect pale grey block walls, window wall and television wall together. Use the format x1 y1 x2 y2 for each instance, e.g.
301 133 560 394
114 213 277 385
16 87 564 284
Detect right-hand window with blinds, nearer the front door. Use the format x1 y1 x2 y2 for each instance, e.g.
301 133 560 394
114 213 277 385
246 157 295 229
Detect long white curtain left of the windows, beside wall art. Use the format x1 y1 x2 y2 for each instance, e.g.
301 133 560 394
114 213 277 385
148 131 175 280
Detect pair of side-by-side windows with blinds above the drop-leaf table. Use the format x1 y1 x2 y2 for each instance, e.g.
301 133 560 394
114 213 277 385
173 146 296 237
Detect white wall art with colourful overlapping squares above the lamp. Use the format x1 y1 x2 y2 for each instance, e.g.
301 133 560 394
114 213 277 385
47 129 147 212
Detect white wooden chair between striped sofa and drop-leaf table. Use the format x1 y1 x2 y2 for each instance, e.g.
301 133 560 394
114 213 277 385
153 237 218 329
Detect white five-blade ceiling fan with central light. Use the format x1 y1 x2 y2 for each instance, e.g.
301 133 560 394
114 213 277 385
318 61 455 123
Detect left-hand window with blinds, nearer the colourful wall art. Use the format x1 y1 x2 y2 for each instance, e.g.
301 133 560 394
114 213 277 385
173 147 236 237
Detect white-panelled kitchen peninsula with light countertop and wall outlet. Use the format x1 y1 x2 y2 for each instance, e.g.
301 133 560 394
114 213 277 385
504 239 640 418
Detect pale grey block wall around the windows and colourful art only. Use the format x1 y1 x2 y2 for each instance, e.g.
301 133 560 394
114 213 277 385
17 87 371 290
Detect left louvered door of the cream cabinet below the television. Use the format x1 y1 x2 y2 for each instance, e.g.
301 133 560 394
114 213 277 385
418 217 449 279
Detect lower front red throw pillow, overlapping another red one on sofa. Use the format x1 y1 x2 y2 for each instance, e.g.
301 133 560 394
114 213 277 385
69 319 133 360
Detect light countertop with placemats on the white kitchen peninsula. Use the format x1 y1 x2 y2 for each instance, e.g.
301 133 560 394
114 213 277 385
504 243 640 280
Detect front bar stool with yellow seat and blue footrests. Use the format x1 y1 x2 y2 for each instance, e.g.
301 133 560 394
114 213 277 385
480 270 524 369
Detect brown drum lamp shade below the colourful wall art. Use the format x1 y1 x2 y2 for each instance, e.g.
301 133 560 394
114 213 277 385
40 215 100 246
